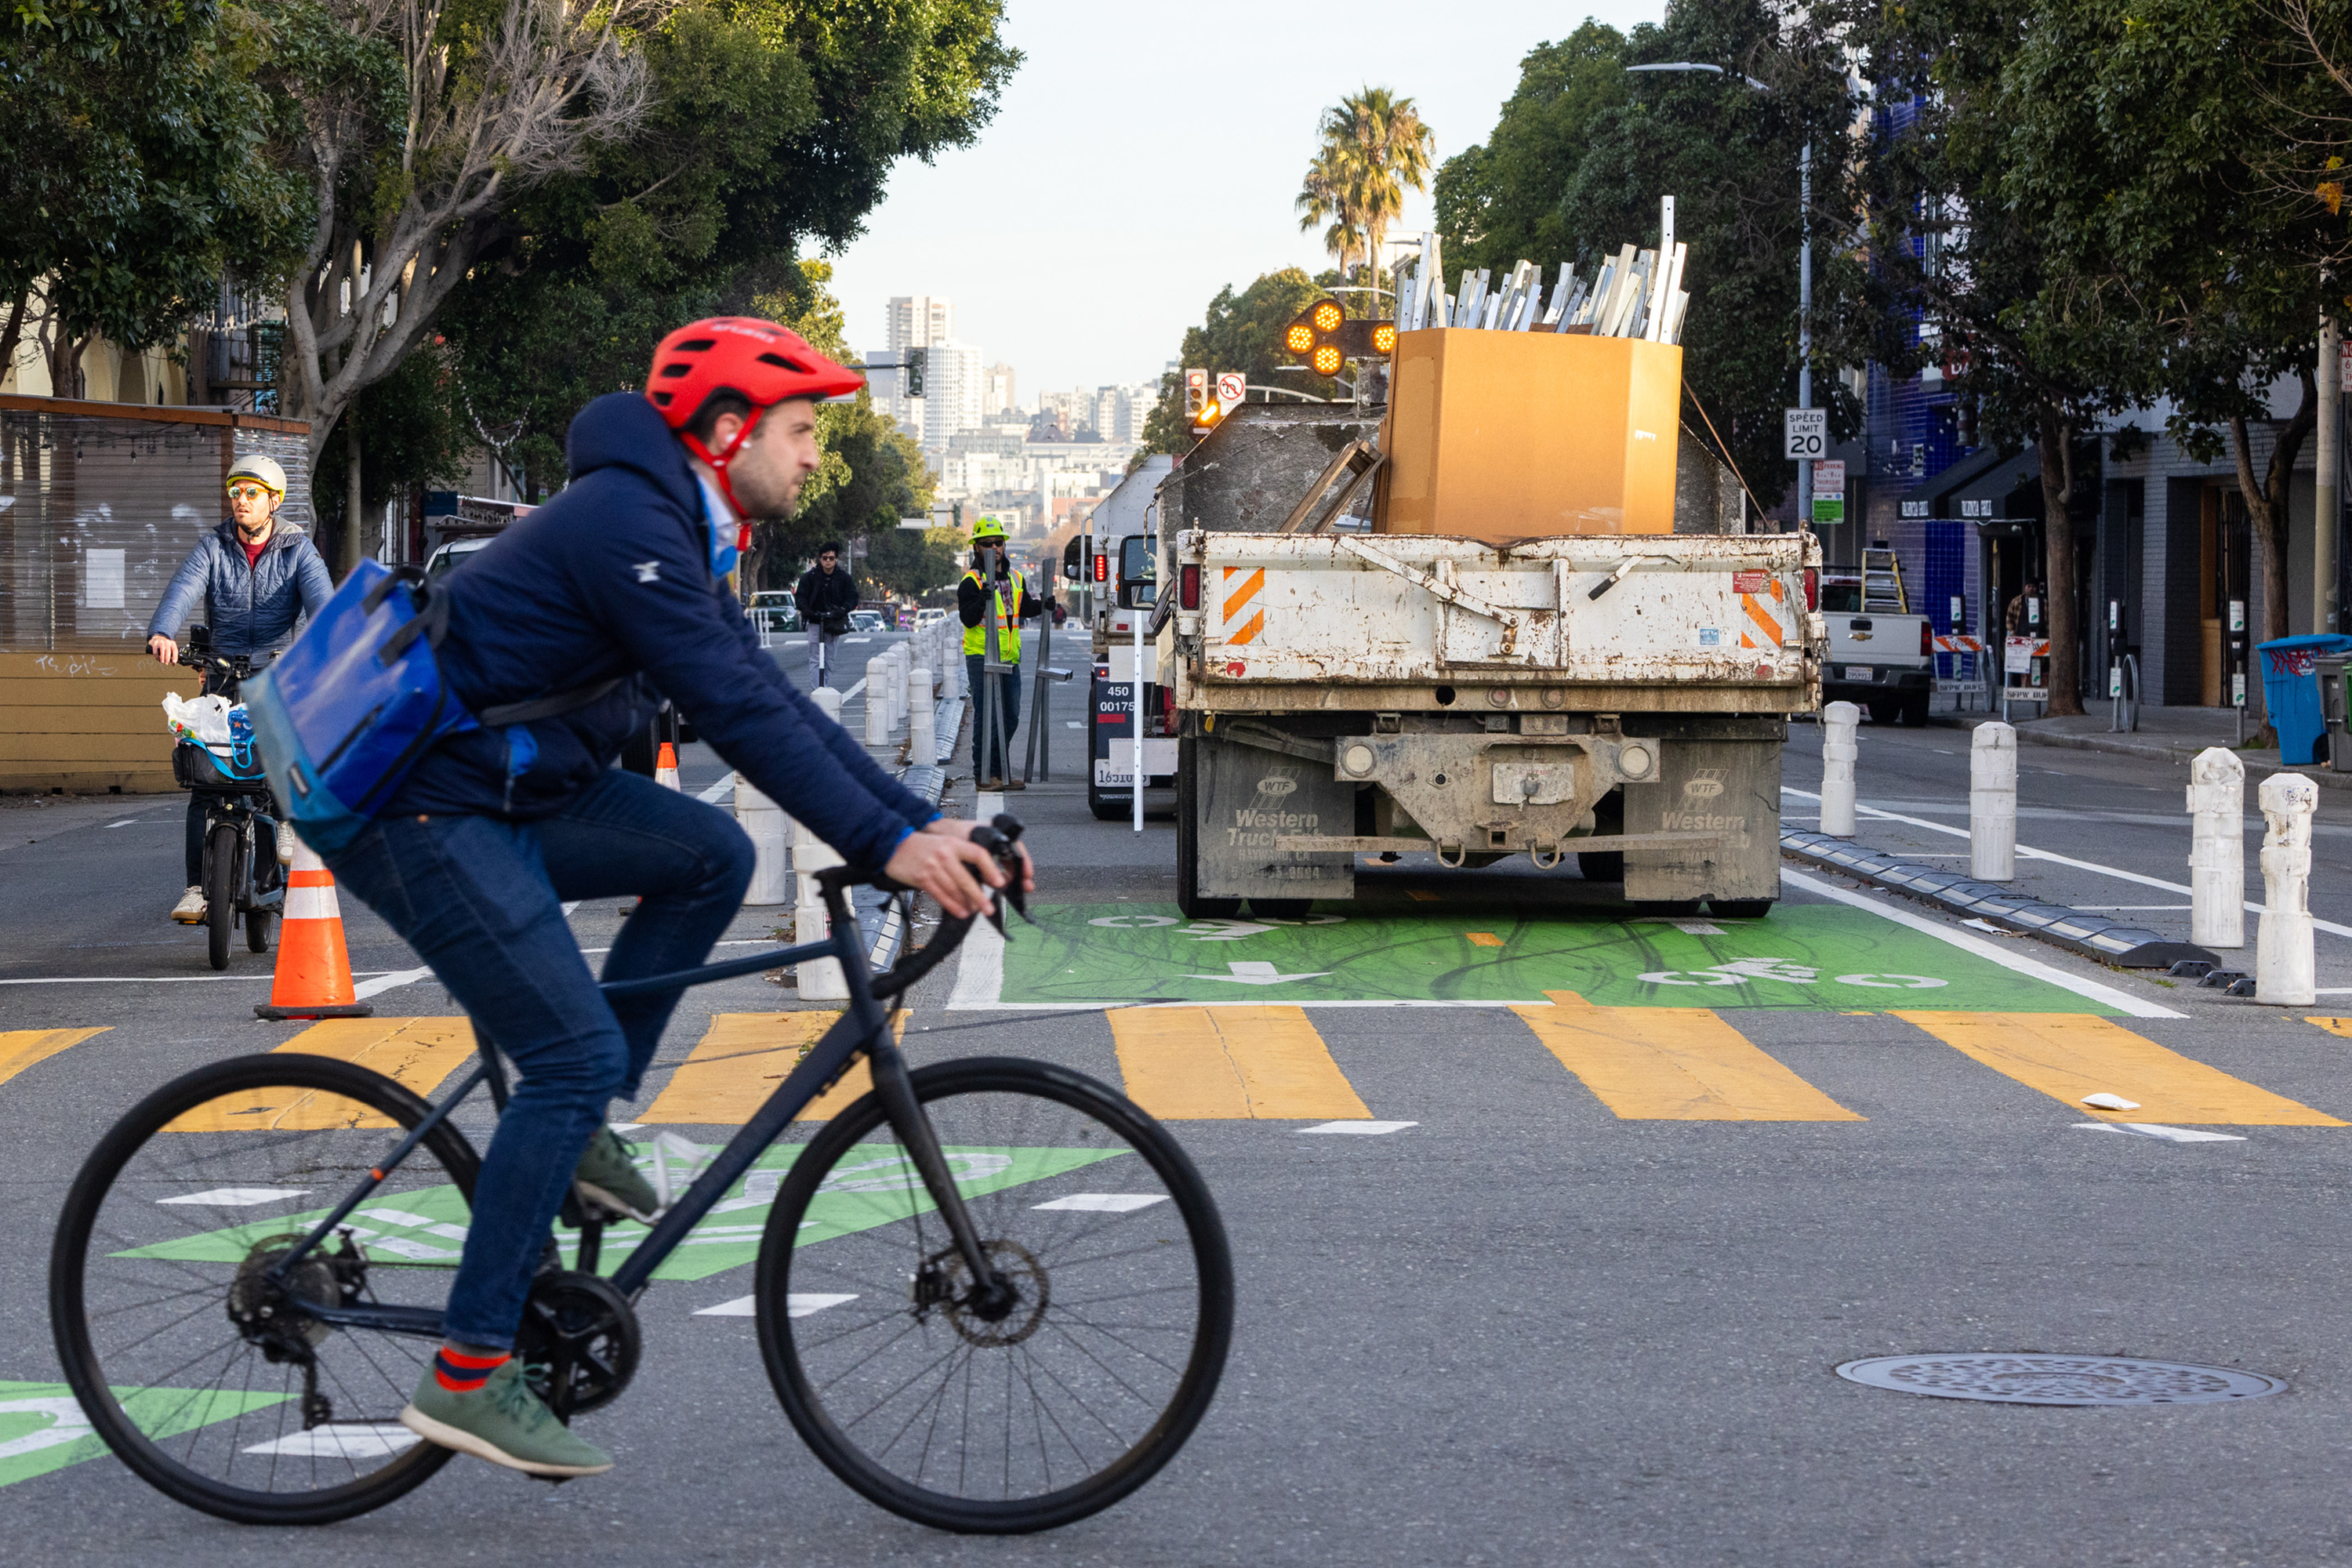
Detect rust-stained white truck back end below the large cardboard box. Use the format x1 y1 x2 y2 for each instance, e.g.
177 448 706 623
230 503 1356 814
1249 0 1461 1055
1160 526 1820 916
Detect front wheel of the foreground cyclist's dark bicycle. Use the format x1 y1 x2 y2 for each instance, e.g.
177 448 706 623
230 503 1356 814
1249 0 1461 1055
757 1058 1232 1535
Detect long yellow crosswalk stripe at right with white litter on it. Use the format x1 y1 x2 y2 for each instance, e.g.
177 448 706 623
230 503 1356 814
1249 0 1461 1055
1893 1013 2345 1126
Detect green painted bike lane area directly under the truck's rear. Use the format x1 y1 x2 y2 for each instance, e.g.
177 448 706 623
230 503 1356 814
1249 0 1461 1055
995 902 2117 1013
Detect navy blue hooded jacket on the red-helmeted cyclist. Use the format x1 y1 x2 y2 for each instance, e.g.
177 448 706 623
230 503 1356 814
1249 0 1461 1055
381 393 938 865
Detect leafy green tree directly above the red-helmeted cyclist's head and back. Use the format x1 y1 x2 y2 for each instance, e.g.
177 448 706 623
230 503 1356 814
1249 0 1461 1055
430 0 1021 503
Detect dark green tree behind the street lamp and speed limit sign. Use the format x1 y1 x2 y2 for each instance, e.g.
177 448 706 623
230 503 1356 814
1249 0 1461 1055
1552 0 1886 506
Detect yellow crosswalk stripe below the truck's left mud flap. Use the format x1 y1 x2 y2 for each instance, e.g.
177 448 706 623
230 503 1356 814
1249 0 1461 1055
1110 1006 1371 1121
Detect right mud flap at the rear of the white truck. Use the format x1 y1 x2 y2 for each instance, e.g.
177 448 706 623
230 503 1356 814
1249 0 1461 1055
1623 741 1780 900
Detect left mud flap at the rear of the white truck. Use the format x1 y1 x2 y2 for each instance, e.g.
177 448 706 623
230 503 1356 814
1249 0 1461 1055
1188 736 1364 898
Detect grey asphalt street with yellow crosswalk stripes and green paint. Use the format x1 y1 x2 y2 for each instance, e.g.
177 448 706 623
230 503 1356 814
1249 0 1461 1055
13 691 2352 1568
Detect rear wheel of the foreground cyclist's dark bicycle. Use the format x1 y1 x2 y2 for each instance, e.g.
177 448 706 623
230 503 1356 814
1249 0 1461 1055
49 1051 477 1523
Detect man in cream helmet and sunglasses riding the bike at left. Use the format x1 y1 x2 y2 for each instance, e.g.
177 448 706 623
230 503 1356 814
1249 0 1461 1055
148 452 334 926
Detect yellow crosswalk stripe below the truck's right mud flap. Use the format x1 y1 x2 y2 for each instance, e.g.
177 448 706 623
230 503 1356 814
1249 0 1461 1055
1510 992 1863 1121
